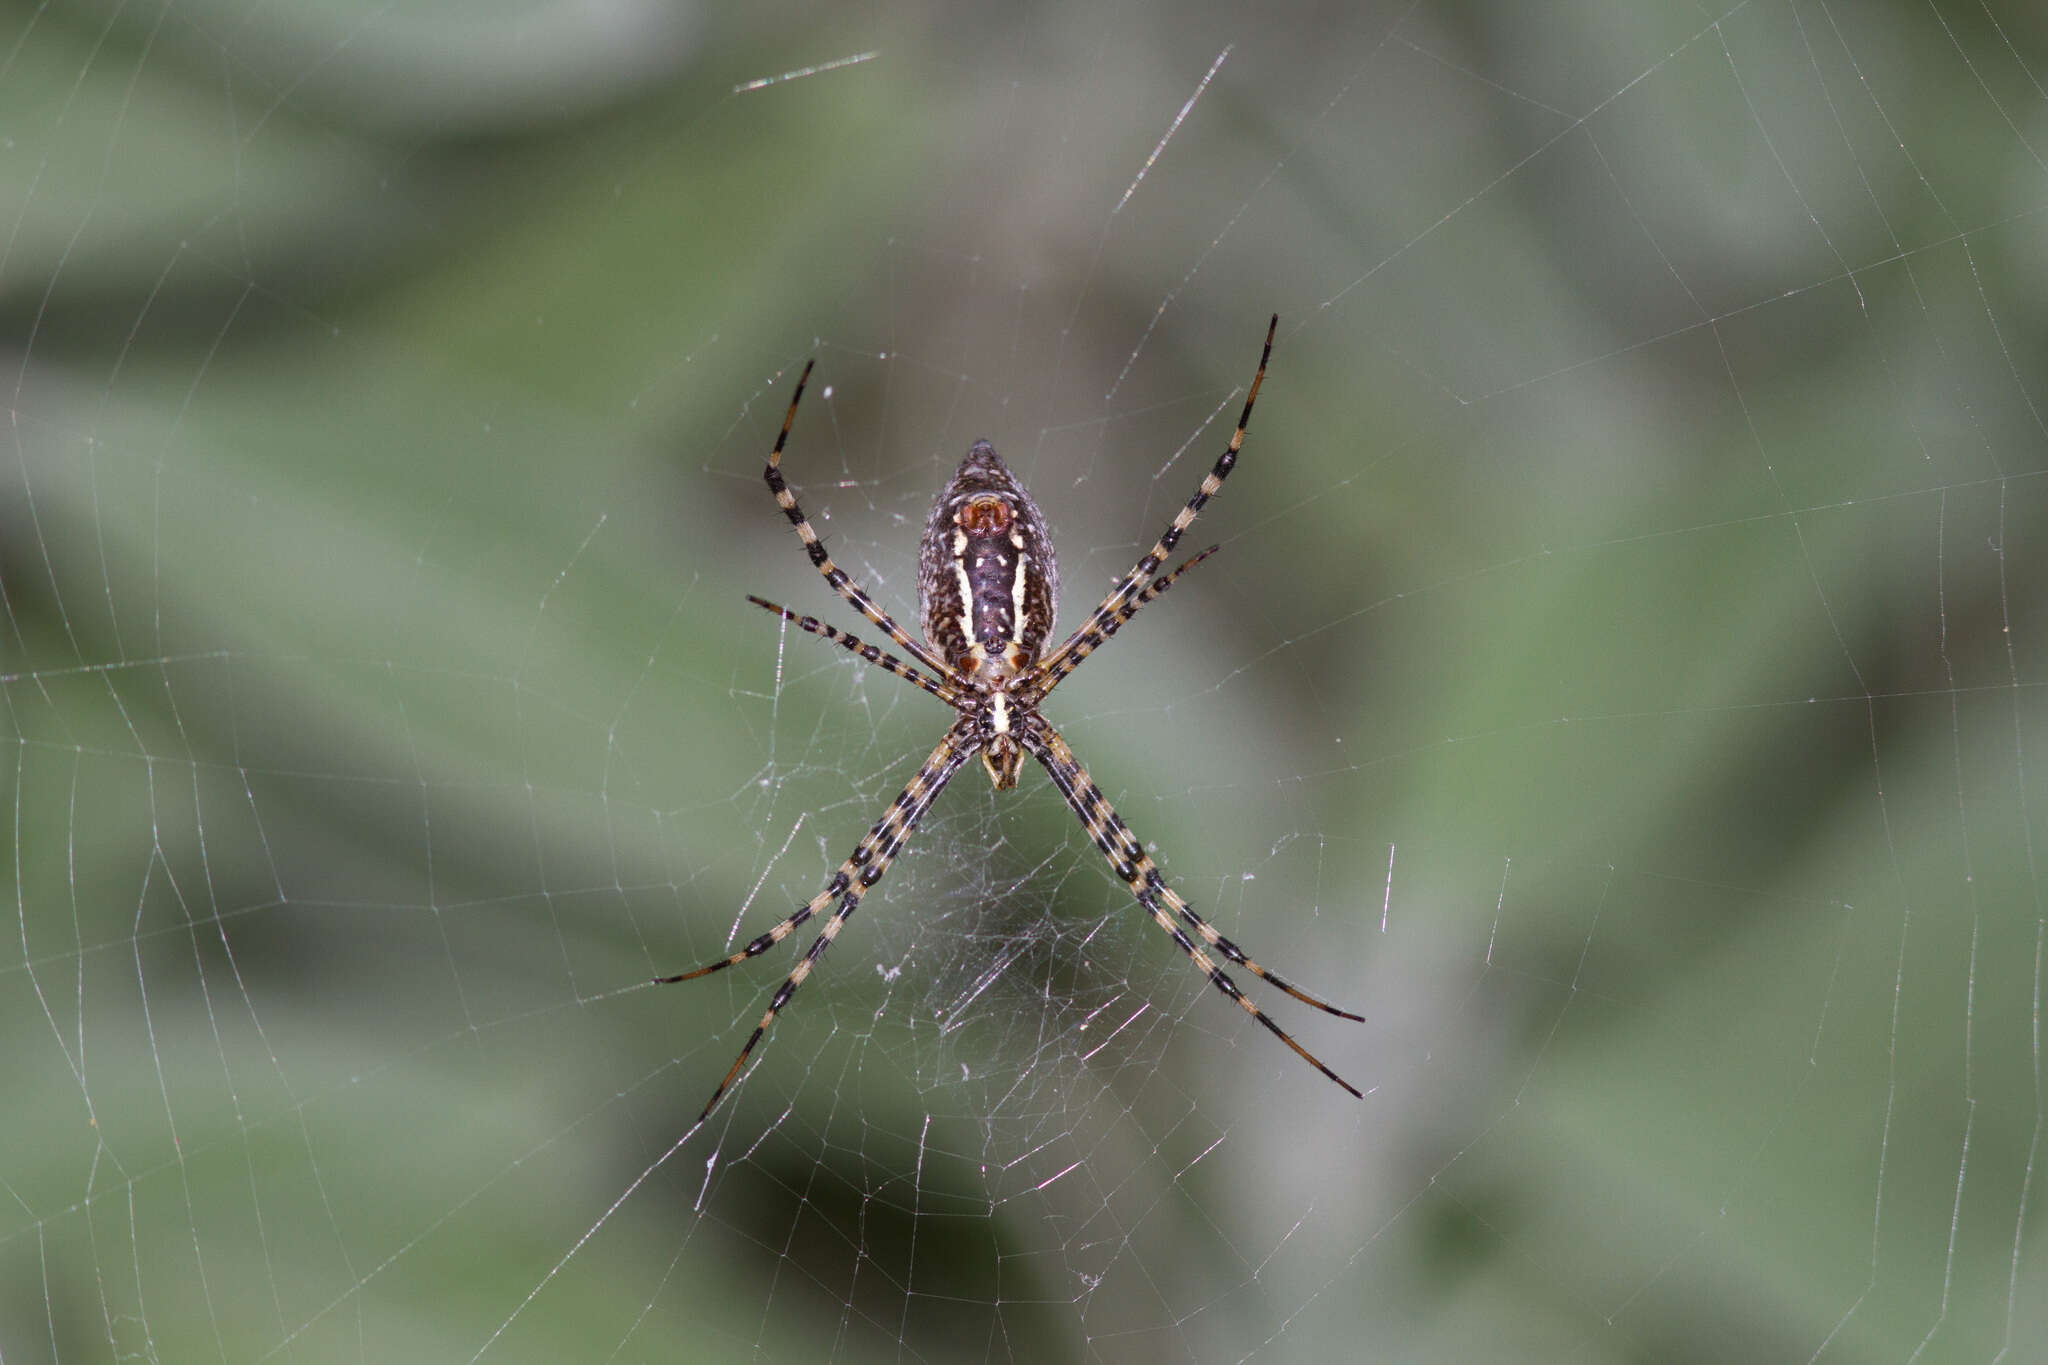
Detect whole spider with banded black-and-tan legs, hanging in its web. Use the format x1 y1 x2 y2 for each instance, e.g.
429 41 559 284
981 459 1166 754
655 313 1364 1124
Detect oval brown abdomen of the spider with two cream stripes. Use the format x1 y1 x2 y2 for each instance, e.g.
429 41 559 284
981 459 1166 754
918 440 1059 681
